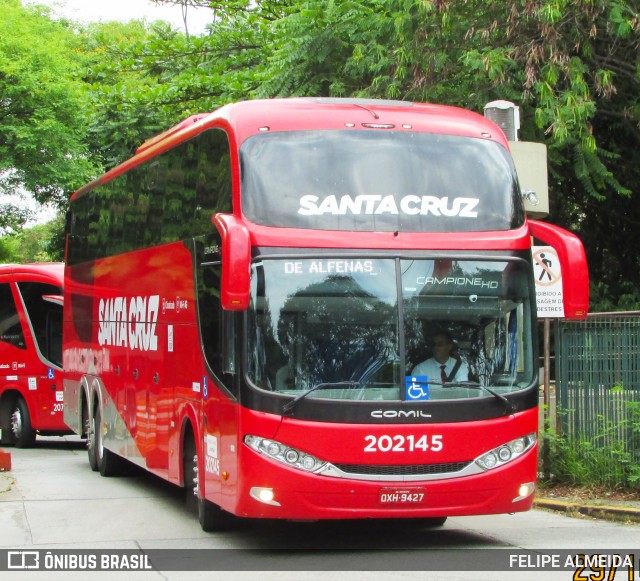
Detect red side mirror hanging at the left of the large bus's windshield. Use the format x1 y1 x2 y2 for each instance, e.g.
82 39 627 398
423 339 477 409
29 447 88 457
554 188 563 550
212 214 251 311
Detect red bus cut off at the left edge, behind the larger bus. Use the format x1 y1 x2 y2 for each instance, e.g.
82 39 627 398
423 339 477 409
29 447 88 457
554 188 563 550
0 263 67 448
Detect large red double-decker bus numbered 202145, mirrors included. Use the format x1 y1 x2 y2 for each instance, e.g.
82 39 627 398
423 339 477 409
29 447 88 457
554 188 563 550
63 98 588 530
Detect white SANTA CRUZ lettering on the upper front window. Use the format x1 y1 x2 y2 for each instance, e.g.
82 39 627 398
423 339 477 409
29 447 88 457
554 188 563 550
298 195 480 218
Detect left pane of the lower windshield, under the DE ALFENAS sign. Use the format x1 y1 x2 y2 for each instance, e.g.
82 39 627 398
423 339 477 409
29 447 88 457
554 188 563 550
249 259 399 399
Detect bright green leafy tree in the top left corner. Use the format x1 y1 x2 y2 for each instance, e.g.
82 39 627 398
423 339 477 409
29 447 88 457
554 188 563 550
0 0 99 204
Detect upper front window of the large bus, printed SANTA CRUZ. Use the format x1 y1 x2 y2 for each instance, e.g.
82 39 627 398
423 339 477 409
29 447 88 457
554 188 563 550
240 130 524 232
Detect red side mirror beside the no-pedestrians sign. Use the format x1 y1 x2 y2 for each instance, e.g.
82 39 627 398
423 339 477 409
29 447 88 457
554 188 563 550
529 220 589 319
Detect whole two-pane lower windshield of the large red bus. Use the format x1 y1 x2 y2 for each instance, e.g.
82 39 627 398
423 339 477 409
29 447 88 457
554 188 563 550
248 257 534 401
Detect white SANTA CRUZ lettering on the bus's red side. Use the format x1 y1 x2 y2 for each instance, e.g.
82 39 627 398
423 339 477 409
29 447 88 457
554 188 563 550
98 295 160 351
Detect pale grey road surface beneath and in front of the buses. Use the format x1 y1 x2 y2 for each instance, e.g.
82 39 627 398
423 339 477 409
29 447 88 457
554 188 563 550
0 437 640 581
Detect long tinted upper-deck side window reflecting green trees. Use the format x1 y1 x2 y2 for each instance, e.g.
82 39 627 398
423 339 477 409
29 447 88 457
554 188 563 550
67 129 232 264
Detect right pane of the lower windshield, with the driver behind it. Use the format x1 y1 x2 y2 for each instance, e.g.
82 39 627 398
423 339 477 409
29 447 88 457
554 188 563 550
401 259 534 399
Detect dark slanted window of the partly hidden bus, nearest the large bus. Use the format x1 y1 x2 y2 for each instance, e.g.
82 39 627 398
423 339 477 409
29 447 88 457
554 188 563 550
18 282 62 366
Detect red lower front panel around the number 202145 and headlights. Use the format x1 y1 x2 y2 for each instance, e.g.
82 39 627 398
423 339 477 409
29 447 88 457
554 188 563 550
222 410 537 519
